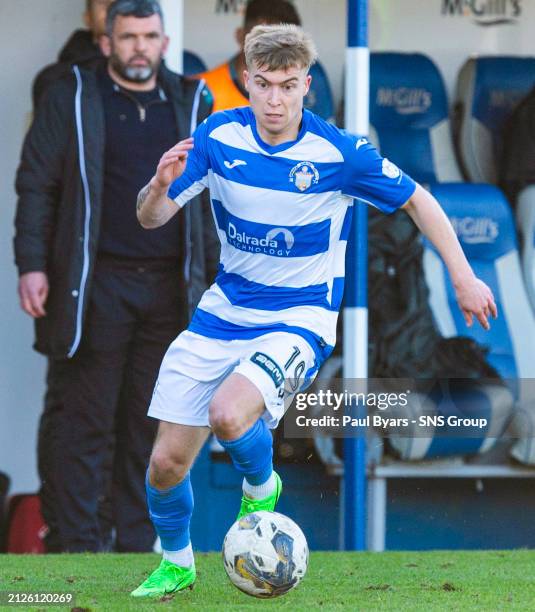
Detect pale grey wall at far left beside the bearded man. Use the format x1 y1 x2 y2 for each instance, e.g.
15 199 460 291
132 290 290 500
0 0 84 492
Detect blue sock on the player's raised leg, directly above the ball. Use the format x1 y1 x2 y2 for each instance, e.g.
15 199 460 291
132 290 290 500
218 419 273 485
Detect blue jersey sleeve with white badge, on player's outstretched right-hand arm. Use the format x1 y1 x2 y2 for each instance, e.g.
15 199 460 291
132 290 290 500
342 134 416 214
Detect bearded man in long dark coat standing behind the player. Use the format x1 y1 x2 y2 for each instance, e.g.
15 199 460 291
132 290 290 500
15 0 211 552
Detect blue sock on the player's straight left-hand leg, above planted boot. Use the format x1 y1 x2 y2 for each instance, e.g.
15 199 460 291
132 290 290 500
145 470 193 550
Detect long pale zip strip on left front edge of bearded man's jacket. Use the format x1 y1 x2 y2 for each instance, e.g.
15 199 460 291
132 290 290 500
67 66 91 359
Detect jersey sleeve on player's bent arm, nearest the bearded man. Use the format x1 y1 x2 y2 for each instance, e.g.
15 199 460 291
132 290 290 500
167 119 210 207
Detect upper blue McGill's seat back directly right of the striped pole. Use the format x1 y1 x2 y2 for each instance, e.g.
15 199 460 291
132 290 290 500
370 52 461 184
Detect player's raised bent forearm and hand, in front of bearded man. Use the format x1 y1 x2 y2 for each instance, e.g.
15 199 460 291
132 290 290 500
137 138 193 229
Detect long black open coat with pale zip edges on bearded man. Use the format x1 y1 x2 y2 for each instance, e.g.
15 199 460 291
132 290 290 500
15 65 218 358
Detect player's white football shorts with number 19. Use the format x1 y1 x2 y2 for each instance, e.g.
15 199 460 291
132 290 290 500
148 330 317 429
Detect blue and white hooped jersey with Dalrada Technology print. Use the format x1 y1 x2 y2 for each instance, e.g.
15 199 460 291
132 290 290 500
169 107 415 363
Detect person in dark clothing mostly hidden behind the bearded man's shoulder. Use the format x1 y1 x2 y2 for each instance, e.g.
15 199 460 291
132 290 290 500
32 0 113 108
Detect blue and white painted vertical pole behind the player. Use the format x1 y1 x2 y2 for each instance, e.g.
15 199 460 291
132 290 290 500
343 0 370 550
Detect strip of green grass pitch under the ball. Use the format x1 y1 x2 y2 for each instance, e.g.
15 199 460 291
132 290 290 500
0 550 535 612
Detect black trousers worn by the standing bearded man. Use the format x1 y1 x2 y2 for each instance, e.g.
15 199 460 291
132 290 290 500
38 258 187 552
